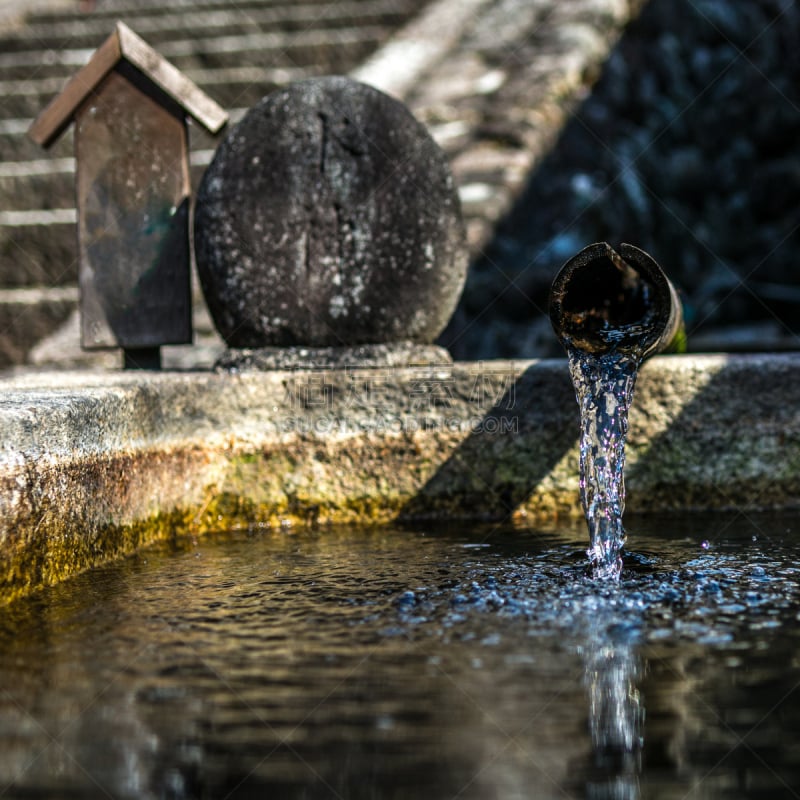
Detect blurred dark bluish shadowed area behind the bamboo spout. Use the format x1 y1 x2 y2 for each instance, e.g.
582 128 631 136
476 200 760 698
442 0 800 358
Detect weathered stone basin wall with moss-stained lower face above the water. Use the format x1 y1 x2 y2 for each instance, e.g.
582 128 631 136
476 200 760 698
0 355 800 602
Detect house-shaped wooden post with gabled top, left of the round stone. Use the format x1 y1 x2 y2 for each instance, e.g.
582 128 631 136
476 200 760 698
29 22 227 368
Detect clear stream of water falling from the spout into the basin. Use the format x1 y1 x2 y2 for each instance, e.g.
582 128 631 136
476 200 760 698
567 347 642 580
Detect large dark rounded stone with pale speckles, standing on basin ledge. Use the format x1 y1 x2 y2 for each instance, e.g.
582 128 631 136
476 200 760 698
194 77 467 347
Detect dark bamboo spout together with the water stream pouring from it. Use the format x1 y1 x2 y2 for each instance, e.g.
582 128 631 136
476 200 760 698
550 242 685 579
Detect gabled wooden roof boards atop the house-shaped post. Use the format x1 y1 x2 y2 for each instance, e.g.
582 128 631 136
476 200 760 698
28 22 228 147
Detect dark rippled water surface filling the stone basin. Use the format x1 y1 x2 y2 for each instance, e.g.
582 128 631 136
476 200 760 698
0 515 800 800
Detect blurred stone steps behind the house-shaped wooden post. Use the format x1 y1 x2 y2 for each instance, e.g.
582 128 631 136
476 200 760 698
0 0 432 368
